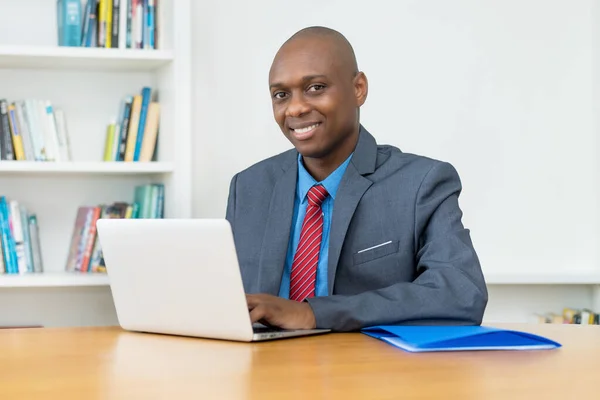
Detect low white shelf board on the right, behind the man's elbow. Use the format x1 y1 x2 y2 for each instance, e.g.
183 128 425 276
484 271 600 285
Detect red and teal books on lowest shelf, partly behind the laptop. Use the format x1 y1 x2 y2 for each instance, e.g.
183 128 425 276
65 184 165 272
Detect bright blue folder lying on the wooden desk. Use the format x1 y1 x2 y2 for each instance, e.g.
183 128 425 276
361 325 561 352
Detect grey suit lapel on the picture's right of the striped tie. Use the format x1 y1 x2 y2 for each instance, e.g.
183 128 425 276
327 126 377 296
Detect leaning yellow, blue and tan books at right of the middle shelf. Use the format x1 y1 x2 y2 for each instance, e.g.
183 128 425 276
103 87 160 161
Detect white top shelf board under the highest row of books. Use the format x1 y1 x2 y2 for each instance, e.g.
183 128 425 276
0 45 174 71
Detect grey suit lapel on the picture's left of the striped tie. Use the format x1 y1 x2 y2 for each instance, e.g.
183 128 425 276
258 153 298 296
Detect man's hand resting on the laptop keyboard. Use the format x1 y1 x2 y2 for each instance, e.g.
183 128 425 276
246 294 316 329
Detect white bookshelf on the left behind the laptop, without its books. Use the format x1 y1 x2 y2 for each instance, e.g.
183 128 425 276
0 0 192 326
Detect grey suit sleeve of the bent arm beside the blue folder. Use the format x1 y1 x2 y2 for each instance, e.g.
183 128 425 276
308 163 488 331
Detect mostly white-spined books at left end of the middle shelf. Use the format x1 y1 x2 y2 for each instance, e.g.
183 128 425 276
0 98 71 161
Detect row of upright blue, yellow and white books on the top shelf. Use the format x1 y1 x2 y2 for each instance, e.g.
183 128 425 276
56 0 158 49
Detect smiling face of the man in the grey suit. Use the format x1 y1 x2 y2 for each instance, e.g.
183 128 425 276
269 36 367 165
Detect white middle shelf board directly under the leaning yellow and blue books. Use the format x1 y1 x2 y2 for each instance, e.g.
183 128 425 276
0 161 175 175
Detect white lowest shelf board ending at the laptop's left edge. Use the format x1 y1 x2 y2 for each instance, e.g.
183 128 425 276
0 272 109 288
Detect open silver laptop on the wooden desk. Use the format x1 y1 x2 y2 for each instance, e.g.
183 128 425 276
96 219 328 342
